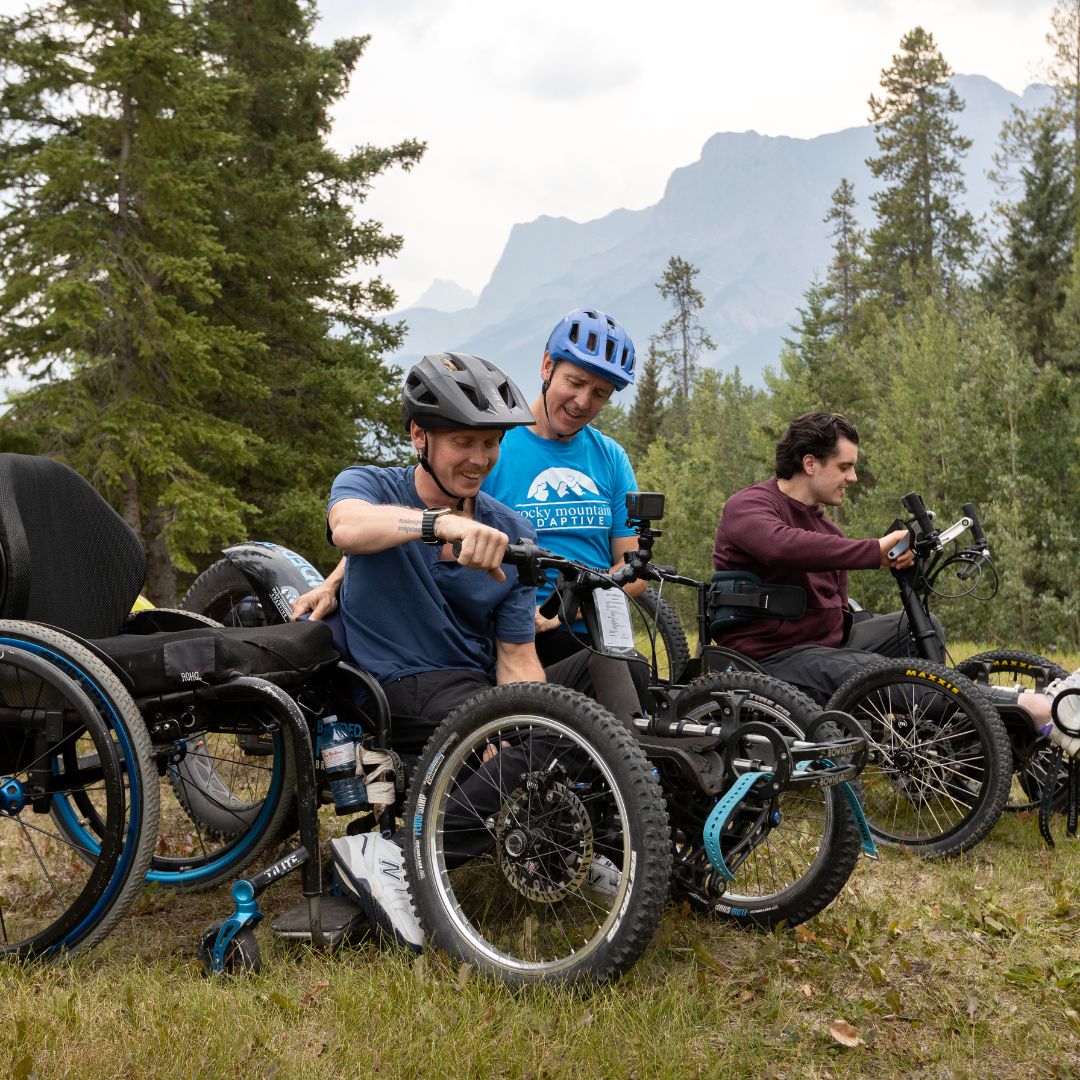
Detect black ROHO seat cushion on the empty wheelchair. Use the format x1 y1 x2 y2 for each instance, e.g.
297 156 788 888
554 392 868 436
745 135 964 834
93 622 339 698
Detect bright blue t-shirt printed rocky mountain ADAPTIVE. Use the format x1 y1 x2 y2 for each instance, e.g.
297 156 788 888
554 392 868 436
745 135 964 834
484 426 637 604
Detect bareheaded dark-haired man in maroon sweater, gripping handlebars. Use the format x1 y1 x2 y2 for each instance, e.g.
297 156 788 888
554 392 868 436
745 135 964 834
713 413 924 704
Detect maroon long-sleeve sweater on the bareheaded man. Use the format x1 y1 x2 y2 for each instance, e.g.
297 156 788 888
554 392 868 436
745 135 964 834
713 477 881 659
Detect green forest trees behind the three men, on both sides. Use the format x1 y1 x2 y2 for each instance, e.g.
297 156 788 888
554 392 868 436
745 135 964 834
0 0 1080 651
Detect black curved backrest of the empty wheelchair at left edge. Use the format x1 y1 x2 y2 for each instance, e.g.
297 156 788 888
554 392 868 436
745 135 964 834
0 454 146 638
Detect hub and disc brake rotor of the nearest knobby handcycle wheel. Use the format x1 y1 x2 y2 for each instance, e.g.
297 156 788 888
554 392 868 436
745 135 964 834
495 782 593 904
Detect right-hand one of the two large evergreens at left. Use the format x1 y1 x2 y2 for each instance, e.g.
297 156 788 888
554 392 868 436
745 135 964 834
199 0 423 557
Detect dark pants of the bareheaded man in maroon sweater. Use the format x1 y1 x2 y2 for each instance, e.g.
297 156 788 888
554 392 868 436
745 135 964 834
758 611 945 705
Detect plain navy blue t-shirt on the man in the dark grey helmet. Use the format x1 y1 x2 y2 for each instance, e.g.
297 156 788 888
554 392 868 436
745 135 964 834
326 465 536 684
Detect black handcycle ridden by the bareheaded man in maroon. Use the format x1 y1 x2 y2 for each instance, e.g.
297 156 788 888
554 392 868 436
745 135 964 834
639 492 1065 856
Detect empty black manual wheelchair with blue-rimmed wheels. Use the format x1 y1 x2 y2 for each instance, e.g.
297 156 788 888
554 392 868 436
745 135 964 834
0 454 349 957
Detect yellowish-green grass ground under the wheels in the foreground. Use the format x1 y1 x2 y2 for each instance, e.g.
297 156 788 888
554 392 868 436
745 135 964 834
0 648 1080 1080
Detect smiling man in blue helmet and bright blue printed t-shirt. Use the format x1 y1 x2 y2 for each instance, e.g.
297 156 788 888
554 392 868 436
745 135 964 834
483 308 646 664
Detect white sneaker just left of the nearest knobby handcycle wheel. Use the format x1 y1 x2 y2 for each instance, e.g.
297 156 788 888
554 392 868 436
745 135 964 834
330 833 423 953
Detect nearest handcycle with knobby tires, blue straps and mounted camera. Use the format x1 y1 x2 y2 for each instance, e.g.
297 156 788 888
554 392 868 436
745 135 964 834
187 492 872 983
